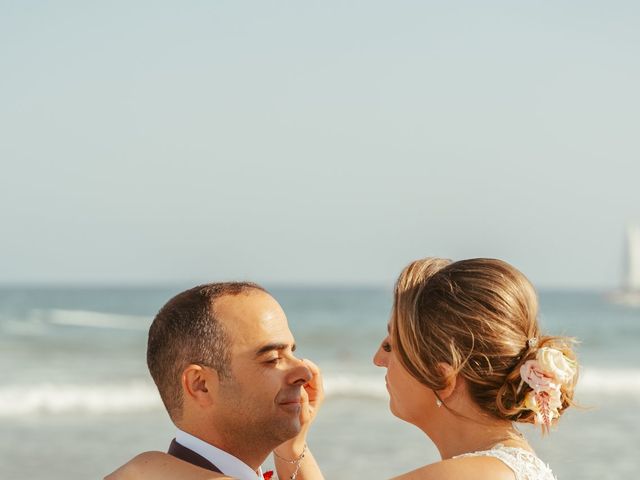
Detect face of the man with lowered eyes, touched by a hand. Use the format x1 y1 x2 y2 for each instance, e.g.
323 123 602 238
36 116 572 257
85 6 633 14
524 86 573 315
215 290 311 444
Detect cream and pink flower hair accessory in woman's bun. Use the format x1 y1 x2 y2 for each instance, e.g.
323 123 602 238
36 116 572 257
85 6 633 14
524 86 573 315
520 347 577 432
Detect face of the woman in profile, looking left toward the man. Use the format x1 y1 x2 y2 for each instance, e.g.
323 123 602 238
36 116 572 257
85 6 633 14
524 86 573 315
373 326 435 424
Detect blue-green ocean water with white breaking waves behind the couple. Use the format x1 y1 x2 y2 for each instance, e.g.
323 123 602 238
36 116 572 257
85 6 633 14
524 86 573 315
0 285 640 480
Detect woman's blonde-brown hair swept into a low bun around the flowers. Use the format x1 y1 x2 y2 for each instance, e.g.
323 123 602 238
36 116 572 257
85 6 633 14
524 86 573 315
391 258 577 423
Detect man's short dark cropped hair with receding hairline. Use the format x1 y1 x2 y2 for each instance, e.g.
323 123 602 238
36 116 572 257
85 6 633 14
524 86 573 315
147 282 266 421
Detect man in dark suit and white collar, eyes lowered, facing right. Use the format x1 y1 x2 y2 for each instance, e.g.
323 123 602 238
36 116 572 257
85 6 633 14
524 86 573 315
115 282 312 480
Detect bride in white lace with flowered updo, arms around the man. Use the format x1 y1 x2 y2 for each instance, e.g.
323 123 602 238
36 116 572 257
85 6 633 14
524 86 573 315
109 258 577 480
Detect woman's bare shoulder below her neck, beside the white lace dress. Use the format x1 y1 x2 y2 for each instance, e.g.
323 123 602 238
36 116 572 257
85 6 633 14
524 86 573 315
393 457 515 480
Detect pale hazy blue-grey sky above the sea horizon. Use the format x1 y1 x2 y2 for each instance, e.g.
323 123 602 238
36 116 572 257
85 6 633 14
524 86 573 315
0 0 640 289
